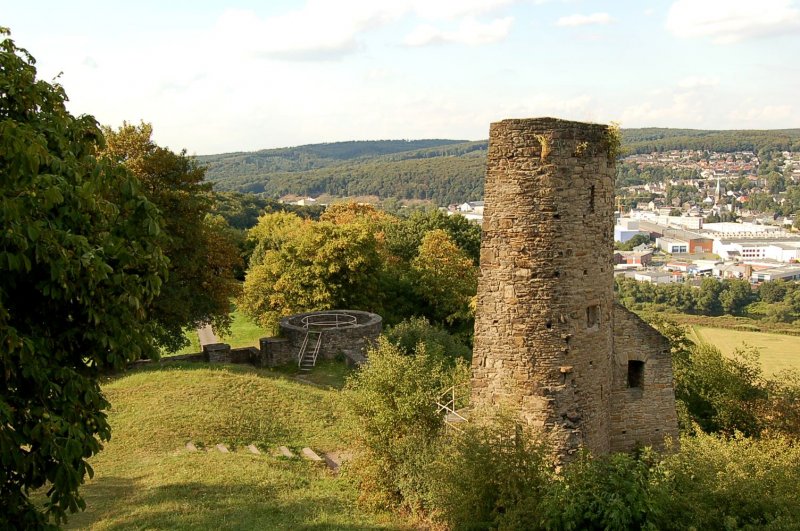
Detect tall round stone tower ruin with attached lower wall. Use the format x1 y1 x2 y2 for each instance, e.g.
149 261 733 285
472 118 677 458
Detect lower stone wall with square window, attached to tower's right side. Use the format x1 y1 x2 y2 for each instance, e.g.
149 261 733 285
611 304 678 451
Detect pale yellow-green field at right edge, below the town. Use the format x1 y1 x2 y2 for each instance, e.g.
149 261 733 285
690 326 800 375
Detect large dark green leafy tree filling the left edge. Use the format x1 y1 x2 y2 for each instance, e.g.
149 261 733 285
0 29 166 529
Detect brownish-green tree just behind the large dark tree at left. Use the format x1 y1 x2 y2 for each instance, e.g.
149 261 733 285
101 123 241 351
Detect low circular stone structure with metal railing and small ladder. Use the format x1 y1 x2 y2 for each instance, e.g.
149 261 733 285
279 310 383 364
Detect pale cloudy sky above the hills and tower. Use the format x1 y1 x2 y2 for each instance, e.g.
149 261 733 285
0 0 800 154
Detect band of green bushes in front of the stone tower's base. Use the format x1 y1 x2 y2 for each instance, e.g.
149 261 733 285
347 334 800 530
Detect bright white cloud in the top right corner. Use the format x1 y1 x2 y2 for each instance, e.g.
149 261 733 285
666 0 800 44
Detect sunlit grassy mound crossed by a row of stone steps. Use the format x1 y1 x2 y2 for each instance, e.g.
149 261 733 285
62 364 411 530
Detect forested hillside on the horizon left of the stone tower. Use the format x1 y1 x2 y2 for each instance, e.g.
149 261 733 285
198 140 486 204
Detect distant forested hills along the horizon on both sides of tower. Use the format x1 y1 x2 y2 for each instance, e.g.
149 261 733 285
197 128 800 205
